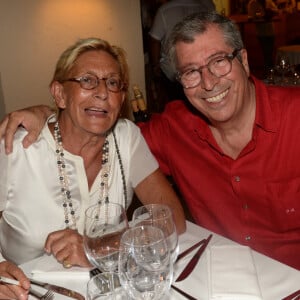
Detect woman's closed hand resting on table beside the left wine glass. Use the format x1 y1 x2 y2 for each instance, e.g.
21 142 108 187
45 229 91 268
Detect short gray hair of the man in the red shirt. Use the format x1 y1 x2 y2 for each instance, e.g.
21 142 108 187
167 12 244 72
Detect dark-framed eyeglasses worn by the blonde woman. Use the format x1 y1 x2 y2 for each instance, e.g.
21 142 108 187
61 74 124 93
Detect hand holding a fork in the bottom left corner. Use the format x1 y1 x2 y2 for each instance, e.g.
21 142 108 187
0 261 30 300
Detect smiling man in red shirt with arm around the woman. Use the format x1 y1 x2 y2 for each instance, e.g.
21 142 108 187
0 13 300 270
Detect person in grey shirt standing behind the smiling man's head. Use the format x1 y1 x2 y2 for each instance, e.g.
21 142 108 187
149 0 215 106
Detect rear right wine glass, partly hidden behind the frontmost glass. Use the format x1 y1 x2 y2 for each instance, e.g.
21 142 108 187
132 204 179 263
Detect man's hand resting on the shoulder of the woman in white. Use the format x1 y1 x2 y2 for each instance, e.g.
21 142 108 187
0 105 53 154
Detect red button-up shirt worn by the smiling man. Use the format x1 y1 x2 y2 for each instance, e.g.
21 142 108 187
141 78 300 269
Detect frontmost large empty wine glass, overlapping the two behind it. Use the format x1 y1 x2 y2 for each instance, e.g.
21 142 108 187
119 225 173 300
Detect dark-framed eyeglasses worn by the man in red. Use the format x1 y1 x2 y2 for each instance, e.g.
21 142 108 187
177 49 241 89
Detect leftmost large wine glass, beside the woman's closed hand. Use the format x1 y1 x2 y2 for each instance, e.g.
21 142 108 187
83 202 128 272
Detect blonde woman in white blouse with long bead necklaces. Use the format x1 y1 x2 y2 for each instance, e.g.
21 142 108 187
0 38 185 299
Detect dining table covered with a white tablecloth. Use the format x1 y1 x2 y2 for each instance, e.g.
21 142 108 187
20 221 300 300
